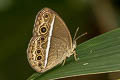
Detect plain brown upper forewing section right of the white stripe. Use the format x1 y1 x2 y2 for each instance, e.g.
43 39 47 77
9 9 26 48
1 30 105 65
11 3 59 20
52 11 72 49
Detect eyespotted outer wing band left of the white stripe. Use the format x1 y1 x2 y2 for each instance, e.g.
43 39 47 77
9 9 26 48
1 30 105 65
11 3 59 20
27 9 53 72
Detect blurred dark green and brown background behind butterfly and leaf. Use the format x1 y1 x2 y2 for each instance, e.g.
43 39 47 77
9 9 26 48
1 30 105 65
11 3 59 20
0 0 120 80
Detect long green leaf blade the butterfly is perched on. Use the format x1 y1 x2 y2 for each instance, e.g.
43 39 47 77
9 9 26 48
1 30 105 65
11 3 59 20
28 28 120 80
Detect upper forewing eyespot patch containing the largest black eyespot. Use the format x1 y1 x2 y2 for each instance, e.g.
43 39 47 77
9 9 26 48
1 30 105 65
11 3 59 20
33 12 51 35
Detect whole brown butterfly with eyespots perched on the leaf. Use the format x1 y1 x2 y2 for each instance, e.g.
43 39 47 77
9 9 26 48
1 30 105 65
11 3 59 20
27 8 86 73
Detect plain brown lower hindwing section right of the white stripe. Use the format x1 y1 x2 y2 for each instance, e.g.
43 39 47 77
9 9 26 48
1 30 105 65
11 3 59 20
43 37 68 72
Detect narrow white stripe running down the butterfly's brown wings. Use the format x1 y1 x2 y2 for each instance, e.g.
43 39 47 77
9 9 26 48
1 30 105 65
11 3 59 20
44 16 55 67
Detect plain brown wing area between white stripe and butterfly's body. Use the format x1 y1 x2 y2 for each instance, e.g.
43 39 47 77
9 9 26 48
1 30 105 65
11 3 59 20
43 10 72 72
